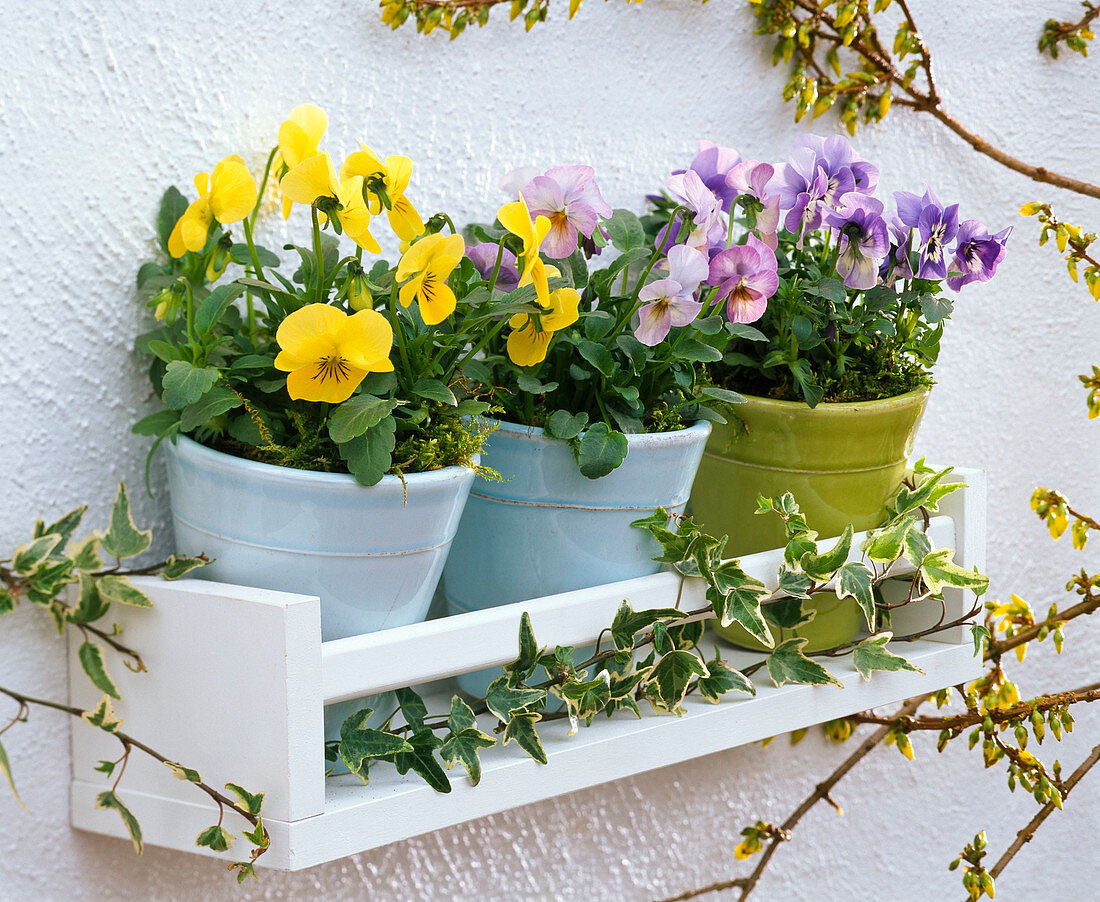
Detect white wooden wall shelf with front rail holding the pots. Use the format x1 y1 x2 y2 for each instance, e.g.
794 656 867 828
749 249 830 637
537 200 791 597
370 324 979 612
69 470 986 870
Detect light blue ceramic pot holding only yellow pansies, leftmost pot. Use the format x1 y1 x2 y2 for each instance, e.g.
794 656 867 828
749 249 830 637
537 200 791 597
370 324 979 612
165 437 474 739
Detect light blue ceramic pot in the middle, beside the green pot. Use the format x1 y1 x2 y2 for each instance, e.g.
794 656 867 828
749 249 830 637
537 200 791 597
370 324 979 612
443 421 711 696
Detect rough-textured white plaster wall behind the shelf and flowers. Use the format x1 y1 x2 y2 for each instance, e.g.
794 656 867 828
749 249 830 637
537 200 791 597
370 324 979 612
0 0 1100 902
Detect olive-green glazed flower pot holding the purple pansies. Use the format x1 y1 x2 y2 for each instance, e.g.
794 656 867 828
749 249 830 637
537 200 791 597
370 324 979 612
690 388 931 651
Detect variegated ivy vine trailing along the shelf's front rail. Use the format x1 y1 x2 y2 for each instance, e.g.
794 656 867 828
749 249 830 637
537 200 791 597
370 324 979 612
326 461 989 792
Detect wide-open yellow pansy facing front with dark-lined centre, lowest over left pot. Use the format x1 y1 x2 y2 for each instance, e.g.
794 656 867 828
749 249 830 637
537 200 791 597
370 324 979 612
275 304 394 404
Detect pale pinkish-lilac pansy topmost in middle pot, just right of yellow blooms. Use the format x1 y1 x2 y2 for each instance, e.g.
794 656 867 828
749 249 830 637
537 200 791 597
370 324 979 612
521 166 612 260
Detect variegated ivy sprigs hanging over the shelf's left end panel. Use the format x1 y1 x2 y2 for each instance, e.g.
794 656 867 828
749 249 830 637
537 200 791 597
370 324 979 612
0 483 270 882
